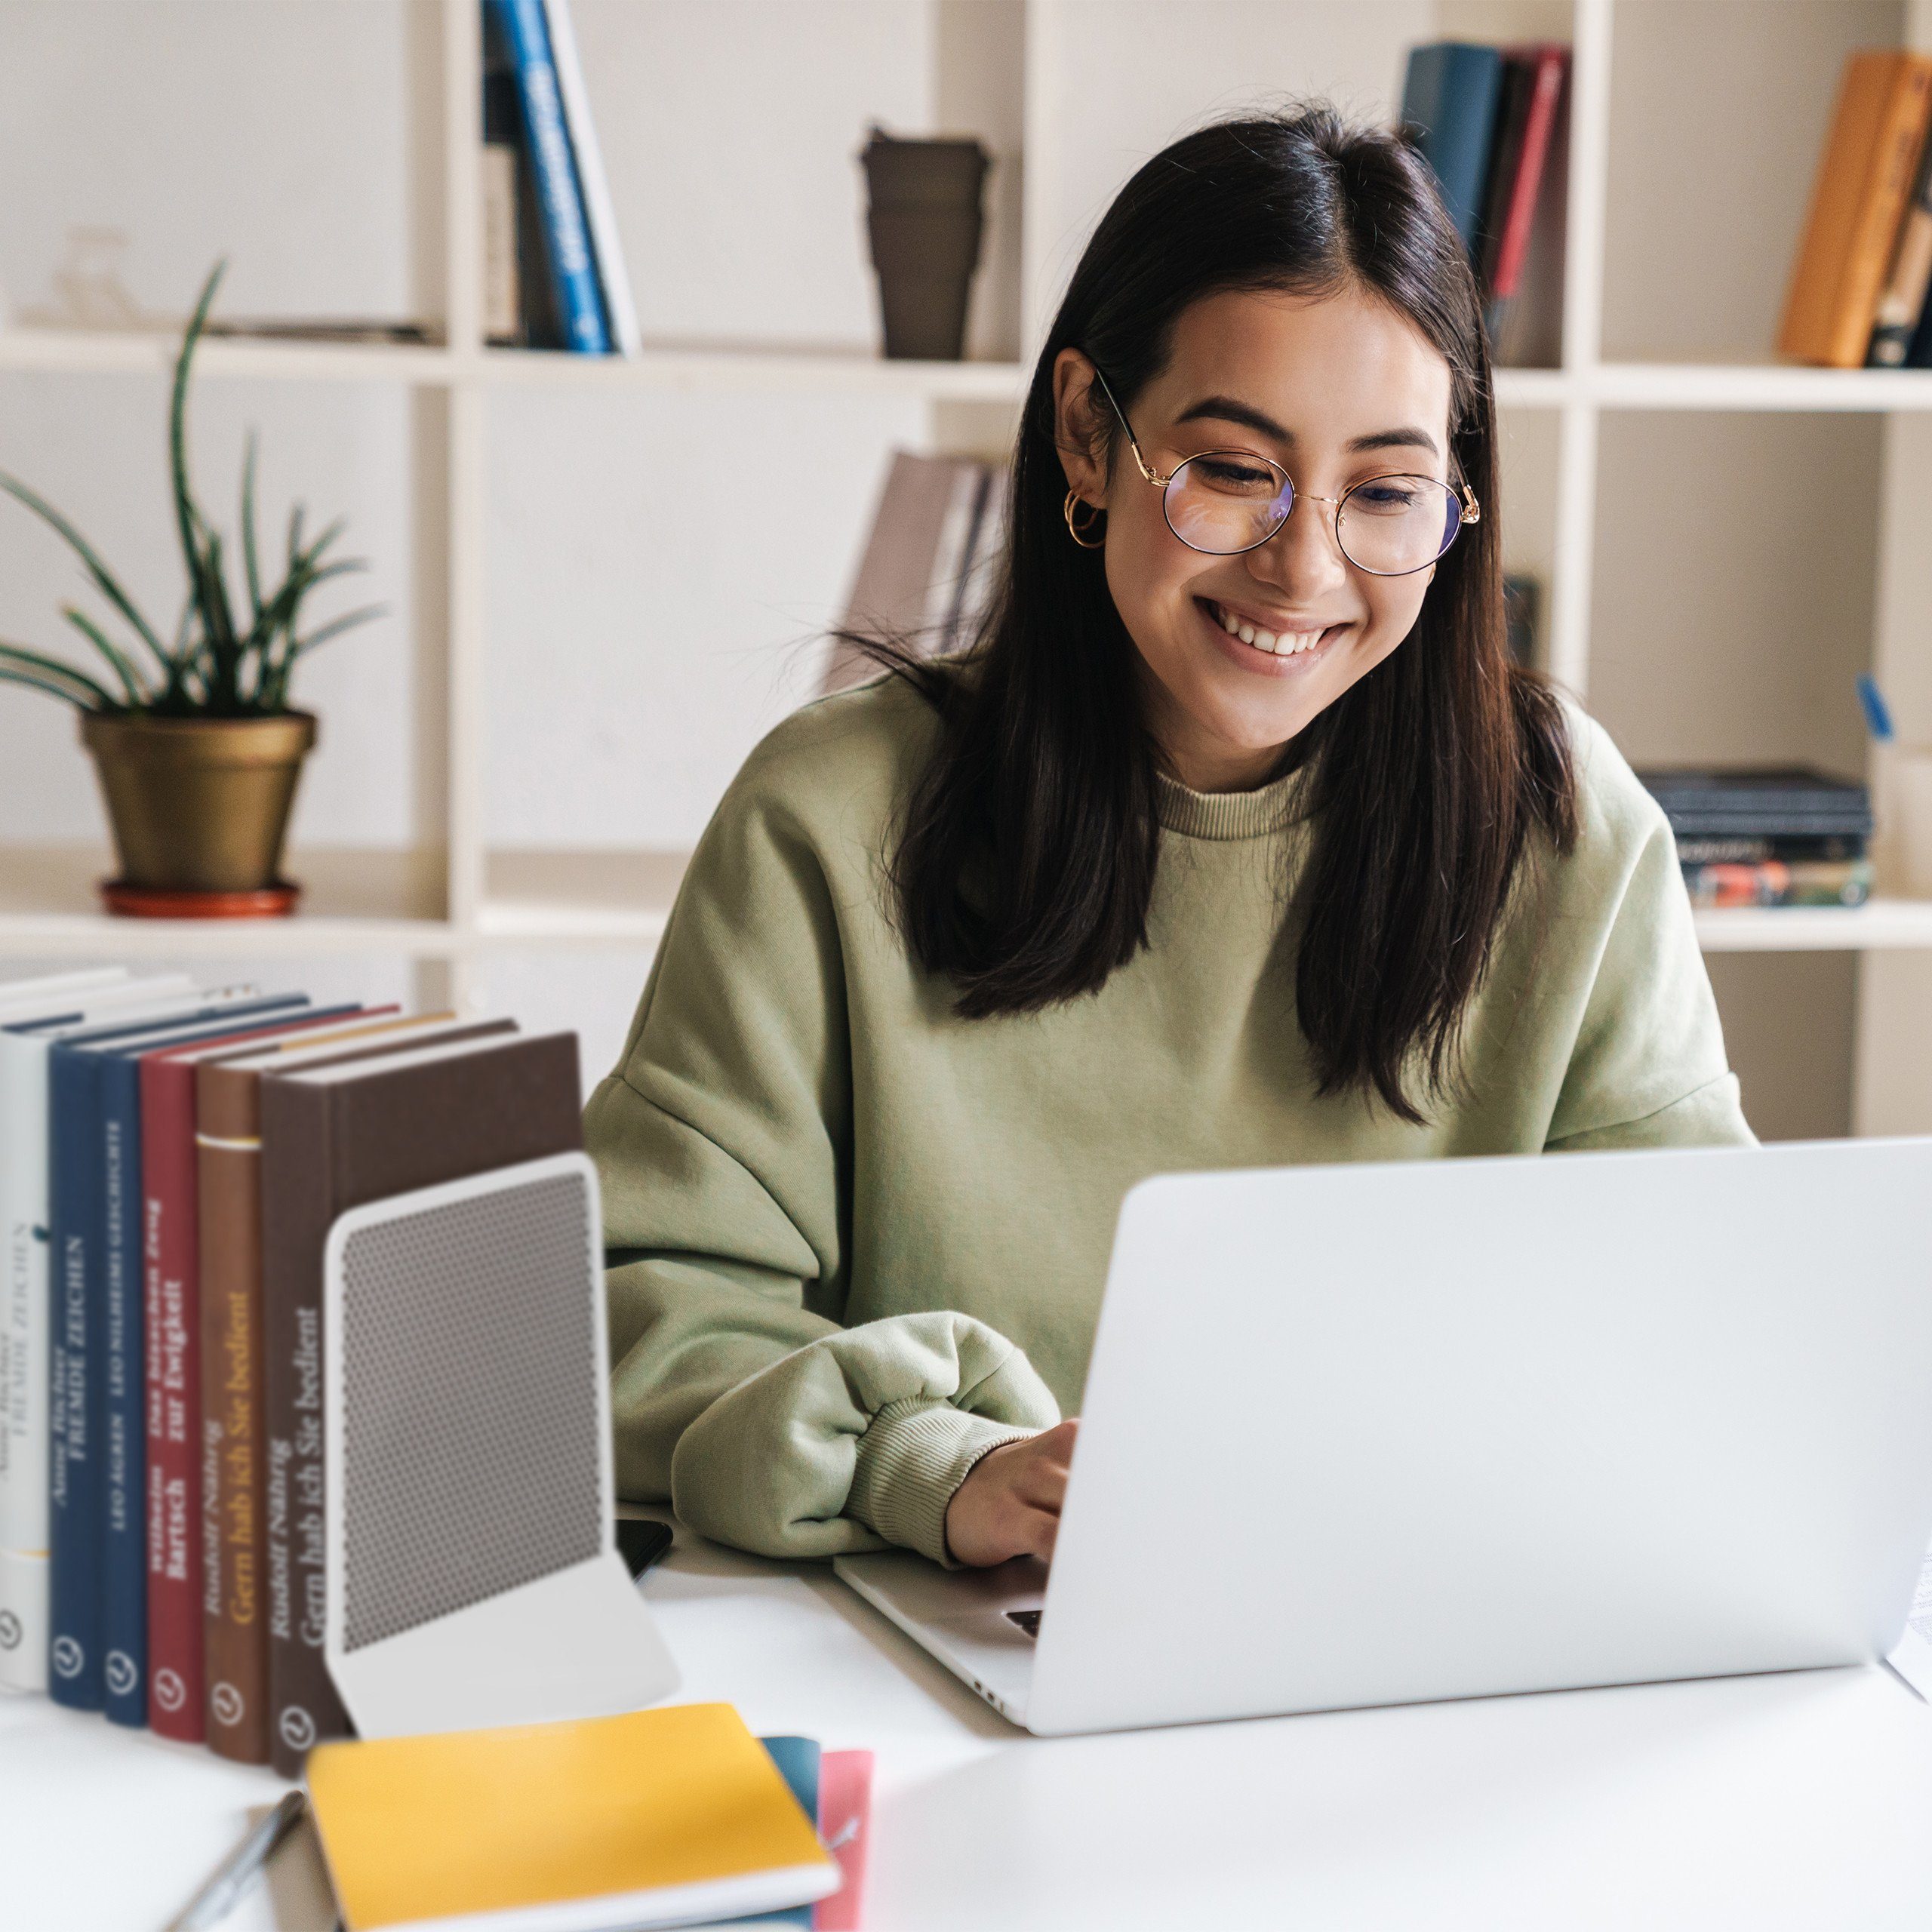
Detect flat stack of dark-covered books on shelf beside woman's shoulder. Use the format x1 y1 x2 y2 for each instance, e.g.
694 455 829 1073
1638 765 1872 906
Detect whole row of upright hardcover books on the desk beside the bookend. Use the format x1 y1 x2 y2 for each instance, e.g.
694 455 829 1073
0 970 582 1776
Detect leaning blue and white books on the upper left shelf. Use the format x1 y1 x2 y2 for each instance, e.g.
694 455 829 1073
483 0 639 355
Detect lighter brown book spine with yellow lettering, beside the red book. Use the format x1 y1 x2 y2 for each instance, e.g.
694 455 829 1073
195 1065 269 1764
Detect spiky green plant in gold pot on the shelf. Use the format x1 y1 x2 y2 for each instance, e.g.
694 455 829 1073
0 263 380 918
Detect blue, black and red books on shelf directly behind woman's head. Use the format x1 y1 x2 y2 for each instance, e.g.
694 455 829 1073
1401 41 1571 367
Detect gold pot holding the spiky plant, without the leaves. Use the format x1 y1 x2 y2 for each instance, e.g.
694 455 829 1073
82 711 315 894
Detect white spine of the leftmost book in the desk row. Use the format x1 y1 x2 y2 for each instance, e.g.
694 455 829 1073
0 1035 51 1690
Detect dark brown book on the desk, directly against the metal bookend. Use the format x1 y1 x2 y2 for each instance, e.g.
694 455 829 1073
261 1034 583 1777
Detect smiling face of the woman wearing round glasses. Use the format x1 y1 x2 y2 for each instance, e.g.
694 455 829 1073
1053 290 1449 790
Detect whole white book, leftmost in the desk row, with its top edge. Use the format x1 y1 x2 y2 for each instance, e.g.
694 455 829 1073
0 974 240 1690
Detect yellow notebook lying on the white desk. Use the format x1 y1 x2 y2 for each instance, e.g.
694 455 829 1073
307 1704 838 1932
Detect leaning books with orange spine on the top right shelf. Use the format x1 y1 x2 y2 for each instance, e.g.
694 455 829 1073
1777 48 1932 369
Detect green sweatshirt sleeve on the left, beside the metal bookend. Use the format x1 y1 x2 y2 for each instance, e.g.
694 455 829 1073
583 737 1059 1563
